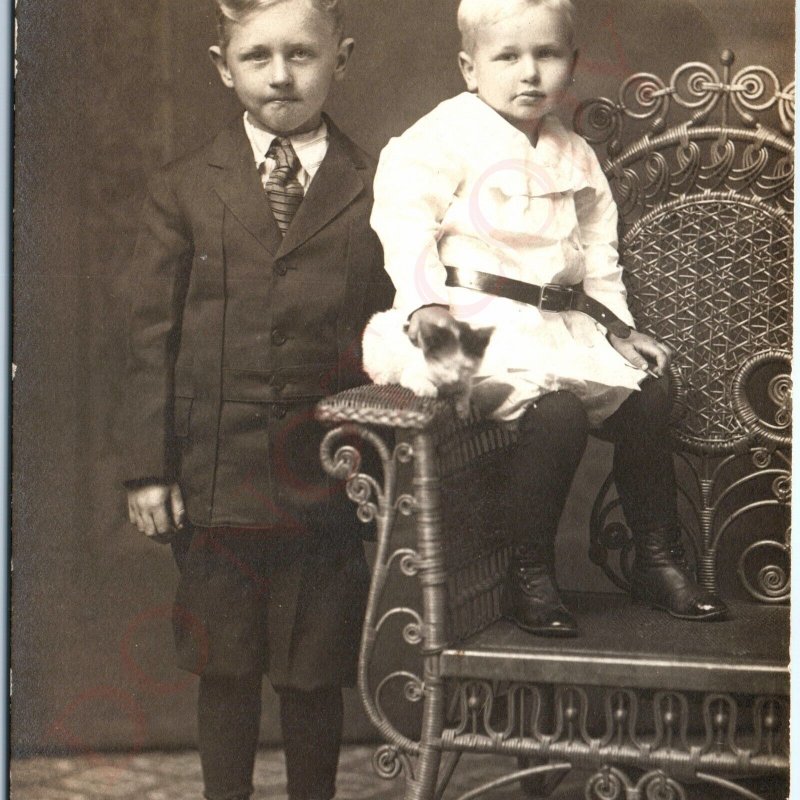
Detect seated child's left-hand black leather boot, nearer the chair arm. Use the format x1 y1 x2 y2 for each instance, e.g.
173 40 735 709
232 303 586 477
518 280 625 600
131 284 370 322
500 545 578 637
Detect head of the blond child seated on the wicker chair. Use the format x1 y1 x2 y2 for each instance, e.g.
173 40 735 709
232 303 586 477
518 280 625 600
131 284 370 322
459 2 577 138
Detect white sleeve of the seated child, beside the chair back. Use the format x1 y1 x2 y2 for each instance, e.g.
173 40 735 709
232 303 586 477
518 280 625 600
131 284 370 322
575 143 633 326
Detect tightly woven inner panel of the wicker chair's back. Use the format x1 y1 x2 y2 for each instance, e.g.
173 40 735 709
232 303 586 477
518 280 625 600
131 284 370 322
623 192 792 453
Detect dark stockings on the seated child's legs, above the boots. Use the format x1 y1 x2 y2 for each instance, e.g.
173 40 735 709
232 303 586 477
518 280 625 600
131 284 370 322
509 377 677 552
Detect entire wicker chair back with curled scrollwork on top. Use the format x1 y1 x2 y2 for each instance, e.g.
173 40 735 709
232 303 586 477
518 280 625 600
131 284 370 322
575 52 794 455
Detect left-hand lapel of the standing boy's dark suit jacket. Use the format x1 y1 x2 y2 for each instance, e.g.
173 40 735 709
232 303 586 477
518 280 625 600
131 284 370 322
208 119 282 254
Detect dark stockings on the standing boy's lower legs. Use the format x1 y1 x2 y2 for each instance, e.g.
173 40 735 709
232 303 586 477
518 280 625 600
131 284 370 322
198 674 342 800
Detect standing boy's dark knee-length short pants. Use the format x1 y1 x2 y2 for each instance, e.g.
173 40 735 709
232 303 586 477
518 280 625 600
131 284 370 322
172 527 369 691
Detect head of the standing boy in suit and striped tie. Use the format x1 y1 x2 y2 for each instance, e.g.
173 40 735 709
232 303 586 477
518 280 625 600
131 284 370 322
210 0 353 136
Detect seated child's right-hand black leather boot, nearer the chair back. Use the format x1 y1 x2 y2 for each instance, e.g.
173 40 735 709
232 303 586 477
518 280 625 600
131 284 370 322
631 527 728 620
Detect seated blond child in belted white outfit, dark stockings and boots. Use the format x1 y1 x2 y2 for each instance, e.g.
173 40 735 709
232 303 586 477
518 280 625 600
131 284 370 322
372 0 726 636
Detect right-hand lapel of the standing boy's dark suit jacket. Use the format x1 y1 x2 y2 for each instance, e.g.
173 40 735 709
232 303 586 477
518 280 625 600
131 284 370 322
277 117 365 257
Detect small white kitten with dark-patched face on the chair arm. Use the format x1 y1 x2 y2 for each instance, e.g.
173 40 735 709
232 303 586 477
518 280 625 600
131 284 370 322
363 309 494 418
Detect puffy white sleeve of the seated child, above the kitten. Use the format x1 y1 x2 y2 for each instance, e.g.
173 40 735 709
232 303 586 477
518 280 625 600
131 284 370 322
371 121 461 314
